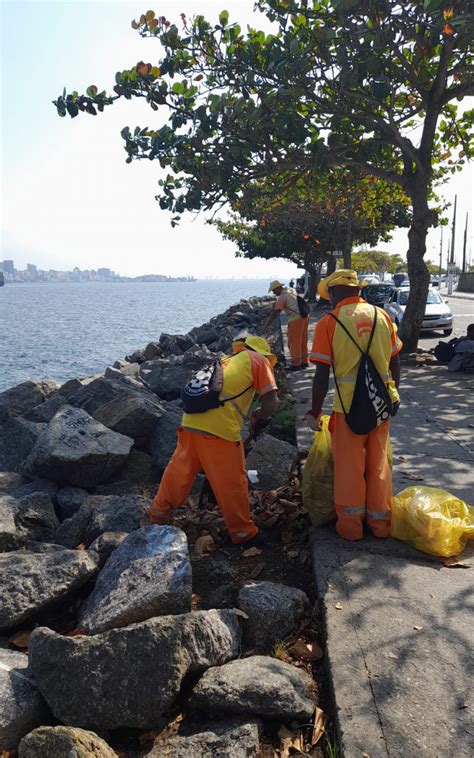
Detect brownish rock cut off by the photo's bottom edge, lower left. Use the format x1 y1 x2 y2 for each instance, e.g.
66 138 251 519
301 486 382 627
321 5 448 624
18 726 117 758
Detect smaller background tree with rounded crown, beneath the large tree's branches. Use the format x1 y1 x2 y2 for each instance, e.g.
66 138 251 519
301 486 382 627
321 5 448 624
215 169 410 295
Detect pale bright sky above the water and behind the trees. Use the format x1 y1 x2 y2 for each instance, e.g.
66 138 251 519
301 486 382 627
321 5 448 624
0 0 474 279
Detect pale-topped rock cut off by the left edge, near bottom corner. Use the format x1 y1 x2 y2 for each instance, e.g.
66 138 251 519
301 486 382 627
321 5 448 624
0 648 51 754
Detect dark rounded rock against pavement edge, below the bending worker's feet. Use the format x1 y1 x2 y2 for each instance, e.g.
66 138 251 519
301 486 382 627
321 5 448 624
237 581 309 653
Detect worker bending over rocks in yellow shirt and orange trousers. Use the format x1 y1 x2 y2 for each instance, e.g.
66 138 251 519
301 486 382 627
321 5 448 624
150 336 278 546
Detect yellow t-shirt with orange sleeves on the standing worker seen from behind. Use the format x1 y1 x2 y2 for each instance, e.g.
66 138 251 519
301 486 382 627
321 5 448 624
309 297 403 413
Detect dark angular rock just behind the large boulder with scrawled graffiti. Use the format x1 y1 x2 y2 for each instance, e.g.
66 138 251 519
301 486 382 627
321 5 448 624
93 390 163 446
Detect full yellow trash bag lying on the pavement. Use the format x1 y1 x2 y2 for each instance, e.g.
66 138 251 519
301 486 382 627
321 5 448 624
391 486 474 558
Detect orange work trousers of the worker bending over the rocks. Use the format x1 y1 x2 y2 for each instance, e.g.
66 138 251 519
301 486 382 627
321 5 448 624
150 428 258 542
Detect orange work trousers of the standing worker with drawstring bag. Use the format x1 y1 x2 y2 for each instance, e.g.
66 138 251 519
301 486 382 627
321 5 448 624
329 413 392 540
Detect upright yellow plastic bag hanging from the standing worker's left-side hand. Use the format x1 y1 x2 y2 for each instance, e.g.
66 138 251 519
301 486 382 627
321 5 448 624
303 416 336 526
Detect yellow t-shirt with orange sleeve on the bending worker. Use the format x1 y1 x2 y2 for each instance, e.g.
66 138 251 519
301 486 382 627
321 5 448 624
182 346 277 442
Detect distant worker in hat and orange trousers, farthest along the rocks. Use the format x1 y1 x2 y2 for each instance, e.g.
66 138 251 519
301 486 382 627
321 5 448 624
265 281 309 371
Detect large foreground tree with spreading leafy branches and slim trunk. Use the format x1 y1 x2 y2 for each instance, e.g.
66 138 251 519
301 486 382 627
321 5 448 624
56 0 474 350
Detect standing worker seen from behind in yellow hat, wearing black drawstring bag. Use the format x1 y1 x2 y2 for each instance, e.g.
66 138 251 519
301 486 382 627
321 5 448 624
308 269 402 540
